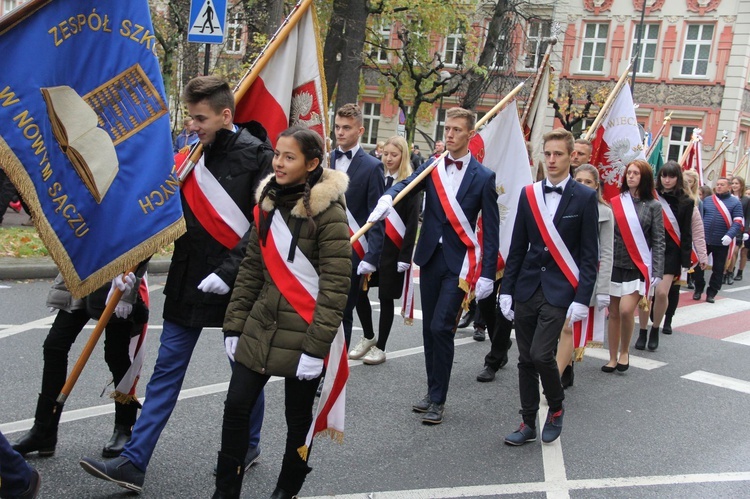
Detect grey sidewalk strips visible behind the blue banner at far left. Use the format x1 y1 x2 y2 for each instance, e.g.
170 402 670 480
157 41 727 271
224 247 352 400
0 208 170 280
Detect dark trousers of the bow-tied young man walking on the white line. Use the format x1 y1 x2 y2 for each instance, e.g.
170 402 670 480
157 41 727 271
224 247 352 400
515 286 567 428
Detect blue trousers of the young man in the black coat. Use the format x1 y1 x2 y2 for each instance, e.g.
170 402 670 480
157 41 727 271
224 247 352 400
122 321 264 471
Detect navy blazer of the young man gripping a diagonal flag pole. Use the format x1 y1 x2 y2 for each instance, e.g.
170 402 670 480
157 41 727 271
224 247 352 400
386 156 500 281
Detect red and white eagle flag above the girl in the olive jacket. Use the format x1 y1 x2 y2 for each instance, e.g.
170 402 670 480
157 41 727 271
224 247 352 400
234 2 327 146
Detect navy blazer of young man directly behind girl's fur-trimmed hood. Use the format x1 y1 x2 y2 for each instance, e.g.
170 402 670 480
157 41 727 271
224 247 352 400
329 146 385 272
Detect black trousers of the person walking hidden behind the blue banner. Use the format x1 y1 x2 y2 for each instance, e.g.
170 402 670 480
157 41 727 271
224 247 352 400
42 309 138 427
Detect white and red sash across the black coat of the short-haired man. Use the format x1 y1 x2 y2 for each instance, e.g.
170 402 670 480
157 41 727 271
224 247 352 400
181 156 250 249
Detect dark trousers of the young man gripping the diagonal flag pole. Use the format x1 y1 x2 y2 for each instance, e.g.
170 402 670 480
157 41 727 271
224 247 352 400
419 247 466 404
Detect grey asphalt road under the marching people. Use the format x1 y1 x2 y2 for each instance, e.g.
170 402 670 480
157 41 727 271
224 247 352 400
0 276 750 498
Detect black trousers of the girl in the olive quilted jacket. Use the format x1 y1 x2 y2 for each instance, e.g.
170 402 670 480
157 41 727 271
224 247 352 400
221 363 320 494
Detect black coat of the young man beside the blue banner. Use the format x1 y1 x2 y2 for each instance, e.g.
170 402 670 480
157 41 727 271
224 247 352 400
164 128 273 327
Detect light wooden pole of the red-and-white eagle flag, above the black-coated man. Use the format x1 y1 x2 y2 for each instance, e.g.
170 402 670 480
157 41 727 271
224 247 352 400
177 0 313 182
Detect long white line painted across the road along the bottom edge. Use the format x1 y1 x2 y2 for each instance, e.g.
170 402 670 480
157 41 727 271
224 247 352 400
308 471 750 499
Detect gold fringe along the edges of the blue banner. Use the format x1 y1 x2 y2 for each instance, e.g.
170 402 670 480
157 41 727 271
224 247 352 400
0 136 186 298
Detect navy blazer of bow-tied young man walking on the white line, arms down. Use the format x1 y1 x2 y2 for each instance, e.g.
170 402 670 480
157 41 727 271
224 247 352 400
500 179 599 308
